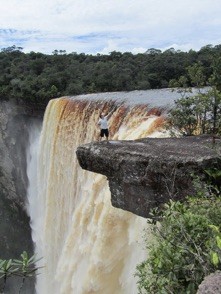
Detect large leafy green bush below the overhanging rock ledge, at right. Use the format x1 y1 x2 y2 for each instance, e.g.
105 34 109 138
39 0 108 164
136 197 221 294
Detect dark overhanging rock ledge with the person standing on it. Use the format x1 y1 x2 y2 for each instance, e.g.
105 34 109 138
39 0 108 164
76 136 221 217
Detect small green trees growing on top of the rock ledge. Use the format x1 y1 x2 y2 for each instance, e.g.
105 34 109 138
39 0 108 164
169 59 221 135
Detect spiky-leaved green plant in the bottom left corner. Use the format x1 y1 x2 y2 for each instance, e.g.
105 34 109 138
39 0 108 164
0 251 40 293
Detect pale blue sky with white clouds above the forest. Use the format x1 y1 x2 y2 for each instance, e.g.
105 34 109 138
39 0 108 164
0 0 221 54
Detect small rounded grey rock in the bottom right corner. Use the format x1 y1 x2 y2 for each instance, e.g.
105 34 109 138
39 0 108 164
197 271 221 294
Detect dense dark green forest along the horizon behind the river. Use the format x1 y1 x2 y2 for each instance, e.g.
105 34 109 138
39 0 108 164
0 45 221 107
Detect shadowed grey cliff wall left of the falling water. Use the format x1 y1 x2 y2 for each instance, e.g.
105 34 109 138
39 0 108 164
0 101 40 293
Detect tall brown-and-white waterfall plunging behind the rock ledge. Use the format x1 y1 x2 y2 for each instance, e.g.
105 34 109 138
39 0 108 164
28 98 169 294
